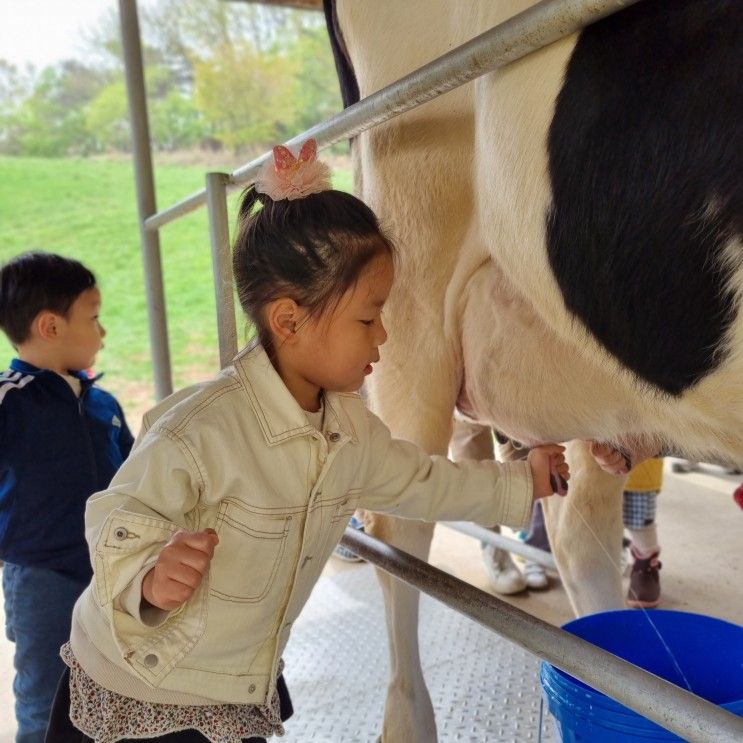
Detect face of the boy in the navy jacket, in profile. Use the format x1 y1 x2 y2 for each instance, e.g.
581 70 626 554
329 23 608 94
57 287 106 371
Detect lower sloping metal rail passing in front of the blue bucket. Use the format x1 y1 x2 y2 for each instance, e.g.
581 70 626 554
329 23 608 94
341 529 743 743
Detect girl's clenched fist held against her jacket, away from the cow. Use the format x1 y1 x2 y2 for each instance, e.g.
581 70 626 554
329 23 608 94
142 529 219 611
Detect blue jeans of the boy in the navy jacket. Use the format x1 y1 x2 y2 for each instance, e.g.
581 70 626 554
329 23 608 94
3 563 86 743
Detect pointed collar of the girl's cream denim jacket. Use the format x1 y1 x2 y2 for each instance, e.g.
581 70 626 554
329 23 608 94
232 345 358 445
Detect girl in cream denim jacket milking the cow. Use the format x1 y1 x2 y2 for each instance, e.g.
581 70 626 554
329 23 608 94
47 140 568 743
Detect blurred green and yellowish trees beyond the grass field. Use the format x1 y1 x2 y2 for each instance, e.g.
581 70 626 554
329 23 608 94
0 0 341 157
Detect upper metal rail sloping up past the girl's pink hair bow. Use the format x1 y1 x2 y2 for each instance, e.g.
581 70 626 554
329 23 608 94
145 0 639 230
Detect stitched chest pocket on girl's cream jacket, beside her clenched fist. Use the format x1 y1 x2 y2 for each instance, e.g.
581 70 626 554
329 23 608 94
209 500 291 602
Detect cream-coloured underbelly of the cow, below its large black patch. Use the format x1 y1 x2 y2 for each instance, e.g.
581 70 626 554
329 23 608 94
460 263 743 462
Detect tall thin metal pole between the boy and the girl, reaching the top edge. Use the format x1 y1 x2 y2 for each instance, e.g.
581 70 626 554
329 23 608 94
119 0 173 400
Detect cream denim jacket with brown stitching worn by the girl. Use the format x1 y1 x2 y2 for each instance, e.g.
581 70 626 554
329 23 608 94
72 347 532 704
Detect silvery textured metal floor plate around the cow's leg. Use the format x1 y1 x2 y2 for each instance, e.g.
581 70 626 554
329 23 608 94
281 564 558 743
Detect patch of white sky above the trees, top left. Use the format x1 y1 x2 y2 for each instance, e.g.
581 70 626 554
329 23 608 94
0 0 118 68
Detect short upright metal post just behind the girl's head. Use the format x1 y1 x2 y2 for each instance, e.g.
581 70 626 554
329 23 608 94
206 173 237 368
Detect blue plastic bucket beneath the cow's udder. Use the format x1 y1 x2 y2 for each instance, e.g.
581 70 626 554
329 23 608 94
541 609 743 743
